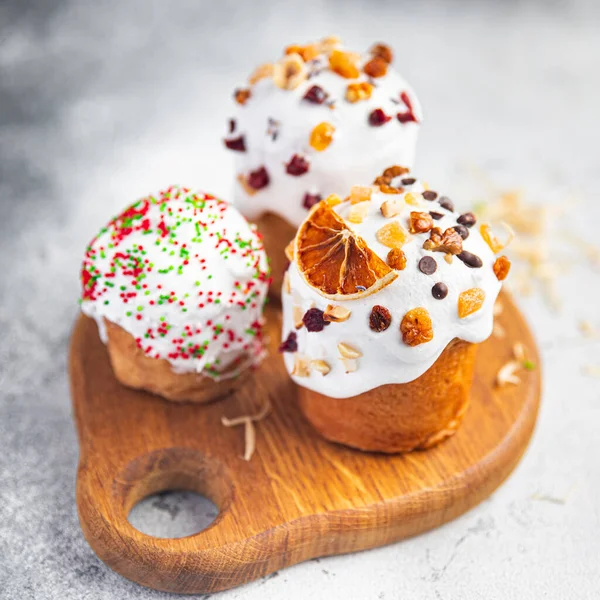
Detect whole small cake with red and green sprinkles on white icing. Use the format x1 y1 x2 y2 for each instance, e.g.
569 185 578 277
81 186 270 403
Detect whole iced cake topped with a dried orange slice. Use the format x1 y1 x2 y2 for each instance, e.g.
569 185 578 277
280 166 510 452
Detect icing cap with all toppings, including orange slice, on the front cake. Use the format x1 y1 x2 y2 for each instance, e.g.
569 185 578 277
280 166 510 398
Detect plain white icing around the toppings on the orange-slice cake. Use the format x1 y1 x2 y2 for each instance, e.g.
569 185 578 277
282 180 501 398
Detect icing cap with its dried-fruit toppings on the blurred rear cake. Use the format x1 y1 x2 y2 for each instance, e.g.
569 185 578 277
225 37 421 227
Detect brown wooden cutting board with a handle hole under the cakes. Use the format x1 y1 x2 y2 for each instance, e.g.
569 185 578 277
70 294 540 593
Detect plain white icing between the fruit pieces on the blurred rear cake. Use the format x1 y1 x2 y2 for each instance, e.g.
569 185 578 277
228 45 422 227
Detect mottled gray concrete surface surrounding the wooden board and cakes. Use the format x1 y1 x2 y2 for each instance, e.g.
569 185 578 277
0 0 600 600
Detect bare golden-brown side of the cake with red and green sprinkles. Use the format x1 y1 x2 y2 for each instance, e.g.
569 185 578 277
104 319 250 404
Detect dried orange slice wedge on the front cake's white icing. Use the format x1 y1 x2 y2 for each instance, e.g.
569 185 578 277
294 202 398 300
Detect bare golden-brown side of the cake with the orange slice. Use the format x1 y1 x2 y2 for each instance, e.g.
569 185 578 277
298 340 477 453
